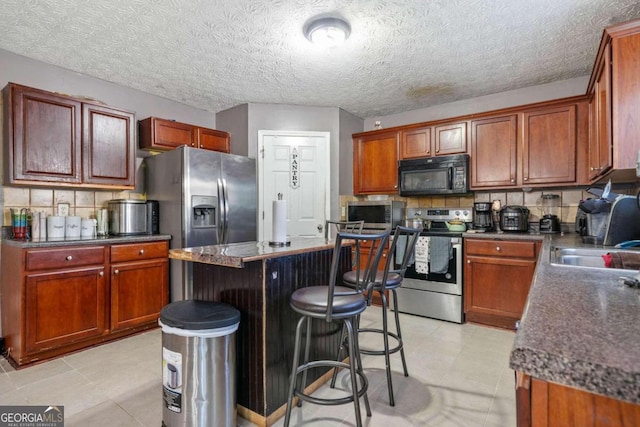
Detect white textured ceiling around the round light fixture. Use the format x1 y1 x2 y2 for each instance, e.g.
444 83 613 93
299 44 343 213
0 0 640 118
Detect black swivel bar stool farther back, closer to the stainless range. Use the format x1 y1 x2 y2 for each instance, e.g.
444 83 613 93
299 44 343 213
331 226 422 406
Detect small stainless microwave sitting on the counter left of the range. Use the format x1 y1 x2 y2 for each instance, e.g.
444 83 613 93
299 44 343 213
347 200 406 229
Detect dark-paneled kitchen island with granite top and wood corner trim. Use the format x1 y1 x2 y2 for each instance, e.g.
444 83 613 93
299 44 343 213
169 238 351 426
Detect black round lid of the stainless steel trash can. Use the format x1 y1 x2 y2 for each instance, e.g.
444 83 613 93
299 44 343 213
160 300 240 330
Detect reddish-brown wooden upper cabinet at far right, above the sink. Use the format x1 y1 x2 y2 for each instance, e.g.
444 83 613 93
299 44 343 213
587 19 640 181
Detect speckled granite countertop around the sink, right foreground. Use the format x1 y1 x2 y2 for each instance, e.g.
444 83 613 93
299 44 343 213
510 234 640 404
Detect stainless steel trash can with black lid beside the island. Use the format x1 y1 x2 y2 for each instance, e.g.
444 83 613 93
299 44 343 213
158 300 240 427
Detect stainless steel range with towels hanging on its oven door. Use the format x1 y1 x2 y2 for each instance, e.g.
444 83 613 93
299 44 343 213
398 208 473 323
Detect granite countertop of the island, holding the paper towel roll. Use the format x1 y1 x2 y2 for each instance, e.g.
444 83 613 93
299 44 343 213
169 237 350 268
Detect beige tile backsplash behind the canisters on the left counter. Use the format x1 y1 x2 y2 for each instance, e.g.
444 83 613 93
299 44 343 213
2 186 145 226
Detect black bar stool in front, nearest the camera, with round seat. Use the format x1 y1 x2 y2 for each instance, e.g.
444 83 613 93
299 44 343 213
284 230 391 427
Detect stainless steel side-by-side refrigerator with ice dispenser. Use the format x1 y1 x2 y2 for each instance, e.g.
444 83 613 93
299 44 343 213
144 146 258 301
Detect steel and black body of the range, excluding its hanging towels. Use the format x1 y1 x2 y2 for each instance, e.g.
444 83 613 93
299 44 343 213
398 208 473 323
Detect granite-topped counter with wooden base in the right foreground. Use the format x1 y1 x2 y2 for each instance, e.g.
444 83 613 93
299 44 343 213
502 235 640 426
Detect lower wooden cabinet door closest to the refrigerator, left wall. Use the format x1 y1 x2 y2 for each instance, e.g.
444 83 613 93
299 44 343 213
111 259 169 331
